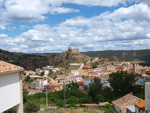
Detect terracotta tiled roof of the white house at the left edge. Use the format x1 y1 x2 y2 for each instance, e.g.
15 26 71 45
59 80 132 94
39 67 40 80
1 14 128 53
0 60 24 74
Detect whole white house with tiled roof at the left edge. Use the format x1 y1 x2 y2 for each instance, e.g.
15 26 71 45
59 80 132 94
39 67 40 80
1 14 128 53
0 61 24 113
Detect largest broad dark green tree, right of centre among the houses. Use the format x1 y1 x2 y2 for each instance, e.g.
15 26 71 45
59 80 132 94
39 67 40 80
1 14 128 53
109 71 137 95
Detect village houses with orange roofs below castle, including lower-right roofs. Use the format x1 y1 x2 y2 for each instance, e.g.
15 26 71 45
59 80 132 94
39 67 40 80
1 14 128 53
20 47 150 113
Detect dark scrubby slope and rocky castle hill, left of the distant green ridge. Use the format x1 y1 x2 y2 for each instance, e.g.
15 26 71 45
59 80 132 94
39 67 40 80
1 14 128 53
0 49 90 70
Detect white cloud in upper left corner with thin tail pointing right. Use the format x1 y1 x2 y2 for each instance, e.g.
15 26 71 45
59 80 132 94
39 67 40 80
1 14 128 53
0 0 79 22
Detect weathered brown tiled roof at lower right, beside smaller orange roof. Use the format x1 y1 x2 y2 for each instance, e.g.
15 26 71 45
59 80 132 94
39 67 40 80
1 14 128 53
112 93 142 113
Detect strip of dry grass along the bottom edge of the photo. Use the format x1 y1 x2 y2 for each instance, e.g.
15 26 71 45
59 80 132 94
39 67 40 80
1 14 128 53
40 107 115 113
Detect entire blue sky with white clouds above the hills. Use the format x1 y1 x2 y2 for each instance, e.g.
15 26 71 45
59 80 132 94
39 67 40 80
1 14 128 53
0 0 150 53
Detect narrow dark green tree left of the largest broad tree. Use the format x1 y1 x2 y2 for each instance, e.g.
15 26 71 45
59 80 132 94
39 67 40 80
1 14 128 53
88 78 102 101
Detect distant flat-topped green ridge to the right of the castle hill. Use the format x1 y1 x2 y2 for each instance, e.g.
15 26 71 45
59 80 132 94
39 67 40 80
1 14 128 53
82 49 150 61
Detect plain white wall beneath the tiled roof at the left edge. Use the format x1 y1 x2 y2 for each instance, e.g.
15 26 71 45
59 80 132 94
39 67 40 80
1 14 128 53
0 72 20 113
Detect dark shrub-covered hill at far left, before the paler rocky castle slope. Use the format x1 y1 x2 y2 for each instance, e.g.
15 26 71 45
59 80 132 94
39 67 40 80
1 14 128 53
0 49 49 70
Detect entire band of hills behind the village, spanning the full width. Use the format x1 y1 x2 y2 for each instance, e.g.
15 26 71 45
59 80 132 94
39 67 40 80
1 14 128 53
0 49 150 70
